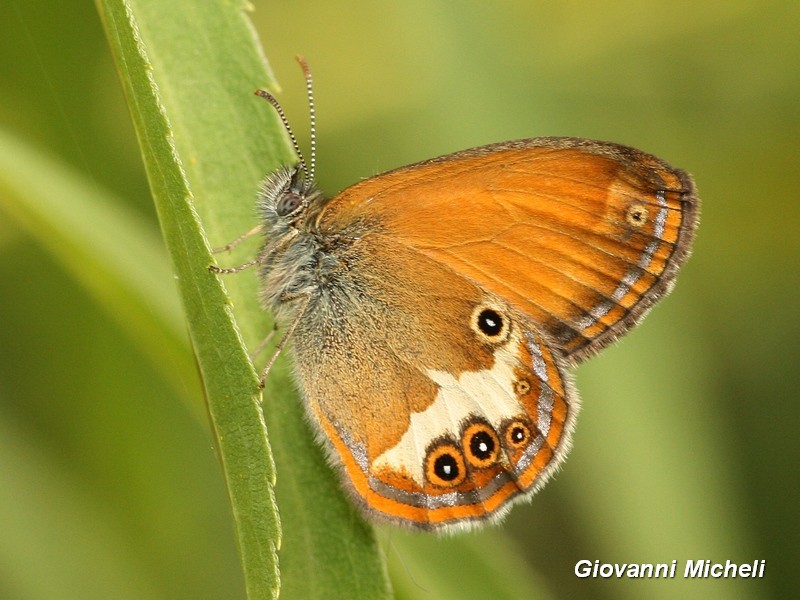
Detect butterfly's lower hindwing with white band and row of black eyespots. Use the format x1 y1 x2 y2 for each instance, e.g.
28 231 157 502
293 232 578 529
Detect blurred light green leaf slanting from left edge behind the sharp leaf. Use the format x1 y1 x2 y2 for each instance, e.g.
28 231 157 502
0 130 198 418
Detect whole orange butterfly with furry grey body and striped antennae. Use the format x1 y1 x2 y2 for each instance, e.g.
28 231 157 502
209 58 699 530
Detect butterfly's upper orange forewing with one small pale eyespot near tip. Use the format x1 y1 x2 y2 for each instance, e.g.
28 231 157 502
317 138 698 362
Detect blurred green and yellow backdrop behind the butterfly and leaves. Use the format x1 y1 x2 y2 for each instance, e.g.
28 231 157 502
0 0 800 599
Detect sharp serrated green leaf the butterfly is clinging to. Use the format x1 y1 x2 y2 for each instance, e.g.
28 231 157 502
98 0 389 598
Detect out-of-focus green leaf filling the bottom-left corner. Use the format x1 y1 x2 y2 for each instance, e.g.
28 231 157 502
0 406 159 600
